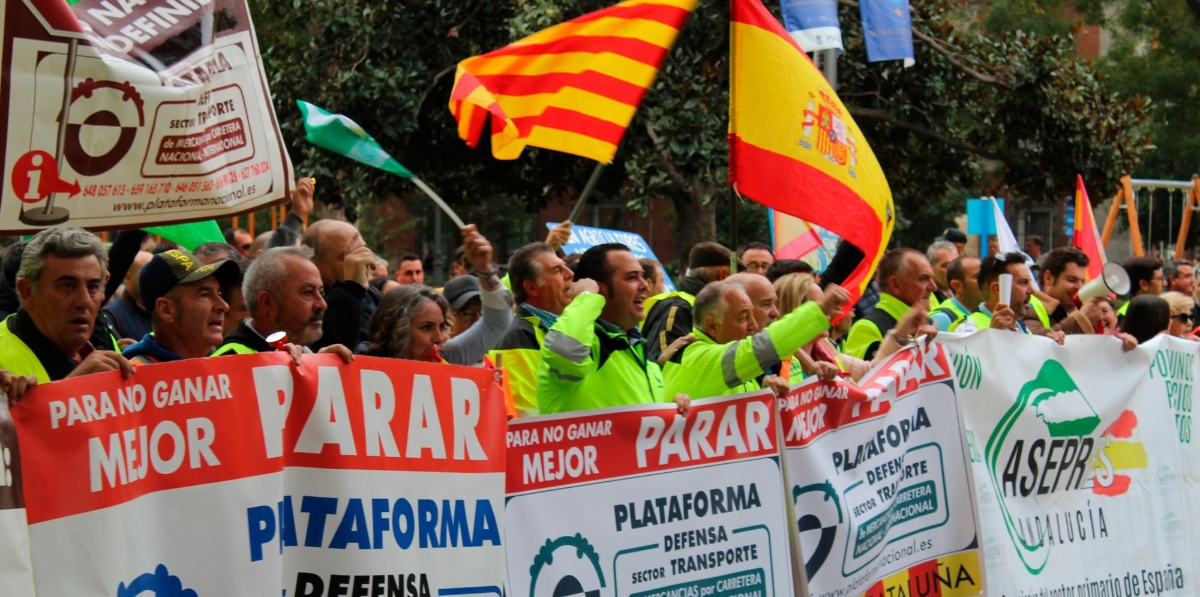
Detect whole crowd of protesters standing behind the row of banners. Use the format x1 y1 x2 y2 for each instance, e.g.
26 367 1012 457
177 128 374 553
0 179 1185 417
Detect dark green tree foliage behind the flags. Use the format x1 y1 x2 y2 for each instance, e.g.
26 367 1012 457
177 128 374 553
250 0 1156 260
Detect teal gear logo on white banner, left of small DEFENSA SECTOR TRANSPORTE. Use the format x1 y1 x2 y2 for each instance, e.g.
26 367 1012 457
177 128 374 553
529 533 605 597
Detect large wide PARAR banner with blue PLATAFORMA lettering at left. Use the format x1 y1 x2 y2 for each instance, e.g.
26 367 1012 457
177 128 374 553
13 354 505 597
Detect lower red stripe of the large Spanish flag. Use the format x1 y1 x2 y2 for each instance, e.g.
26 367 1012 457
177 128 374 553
730 134 883 303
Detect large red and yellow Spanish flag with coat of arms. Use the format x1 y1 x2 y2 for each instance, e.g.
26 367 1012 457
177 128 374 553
730 0 895 300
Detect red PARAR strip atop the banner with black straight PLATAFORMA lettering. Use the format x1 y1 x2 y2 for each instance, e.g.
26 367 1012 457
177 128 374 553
505 393 779 495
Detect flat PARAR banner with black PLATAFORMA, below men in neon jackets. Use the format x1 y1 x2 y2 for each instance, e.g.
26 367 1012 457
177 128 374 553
505 393 793 597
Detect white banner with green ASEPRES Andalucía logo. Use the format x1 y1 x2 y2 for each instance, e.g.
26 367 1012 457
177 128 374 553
946 330 1200 597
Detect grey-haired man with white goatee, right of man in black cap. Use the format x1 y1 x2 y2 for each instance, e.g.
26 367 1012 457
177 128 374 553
212 247 354 362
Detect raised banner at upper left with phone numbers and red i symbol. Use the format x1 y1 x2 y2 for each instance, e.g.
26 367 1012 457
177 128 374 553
0 0 292 233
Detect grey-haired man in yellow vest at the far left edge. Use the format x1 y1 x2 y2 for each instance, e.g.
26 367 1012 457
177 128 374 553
0 228 133 400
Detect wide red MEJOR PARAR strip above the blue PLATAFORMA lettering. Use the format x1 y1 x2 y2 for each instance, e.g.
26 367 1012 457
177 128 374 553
12 352 506 524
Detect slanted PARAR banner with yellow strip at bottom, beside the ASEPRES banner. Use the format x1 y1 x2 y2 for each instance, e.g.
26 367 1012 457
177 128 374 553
780 344 985 597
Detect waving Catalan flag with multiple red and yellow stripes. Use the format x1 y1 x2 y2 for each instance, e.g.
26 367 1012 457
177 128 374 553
450 0 696 163
